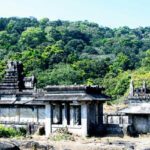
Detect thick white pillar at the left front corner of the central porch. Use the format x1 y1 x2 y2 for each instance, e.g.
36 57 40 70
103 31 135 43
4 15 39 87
45 103 52 137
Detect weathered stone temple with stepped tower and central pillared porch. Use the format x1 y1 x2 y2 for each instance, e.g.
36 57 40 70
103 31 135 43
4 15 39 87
0 61 111 137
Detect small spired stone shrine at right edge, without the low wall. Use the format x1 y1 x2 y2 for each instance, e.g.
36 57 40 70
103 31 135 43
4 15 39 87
119 81 150 134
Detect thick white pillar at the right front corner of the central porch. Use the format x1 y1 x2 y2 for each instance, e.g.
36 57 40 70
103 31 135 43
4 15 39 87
81 103 88 137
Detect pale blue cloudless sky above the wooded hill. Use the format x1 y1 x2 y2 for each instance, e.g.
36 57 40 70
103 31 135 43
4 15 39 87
0 0 150 28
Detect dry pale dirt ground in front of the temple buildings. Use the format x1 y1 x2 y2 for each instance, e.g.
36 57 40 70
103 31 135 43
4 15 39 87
0 135 150 150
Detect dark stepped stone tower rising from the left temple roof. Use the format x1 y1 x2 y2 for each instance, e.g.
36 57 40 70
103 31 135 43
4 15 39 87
0 61 36 94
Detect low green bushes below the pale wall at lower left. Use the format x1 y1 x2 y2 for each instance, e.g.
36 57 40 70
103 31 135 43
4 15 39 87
0 125 26 138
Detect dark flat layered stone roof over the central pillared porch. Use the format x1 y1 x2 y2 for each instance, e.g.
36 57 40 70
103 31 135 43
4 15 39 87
36 85 111 101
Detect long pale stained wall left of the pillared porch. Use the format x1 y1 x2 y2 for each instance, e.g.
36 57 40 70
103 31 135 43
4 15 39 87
0 106 45 123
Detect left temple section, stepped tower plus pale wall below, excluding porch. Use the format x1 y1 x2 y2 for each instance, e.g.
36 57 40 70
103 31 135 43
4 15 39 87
0 61 45 132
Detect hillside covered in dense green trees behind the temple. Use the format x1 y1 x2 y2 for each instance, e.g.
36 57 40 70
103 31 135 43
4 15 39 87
0 17 150 99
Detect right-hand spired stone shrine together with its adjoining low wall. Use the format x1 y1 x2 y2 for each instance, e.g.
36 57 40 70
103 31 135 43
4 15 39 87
103 80 150 136
